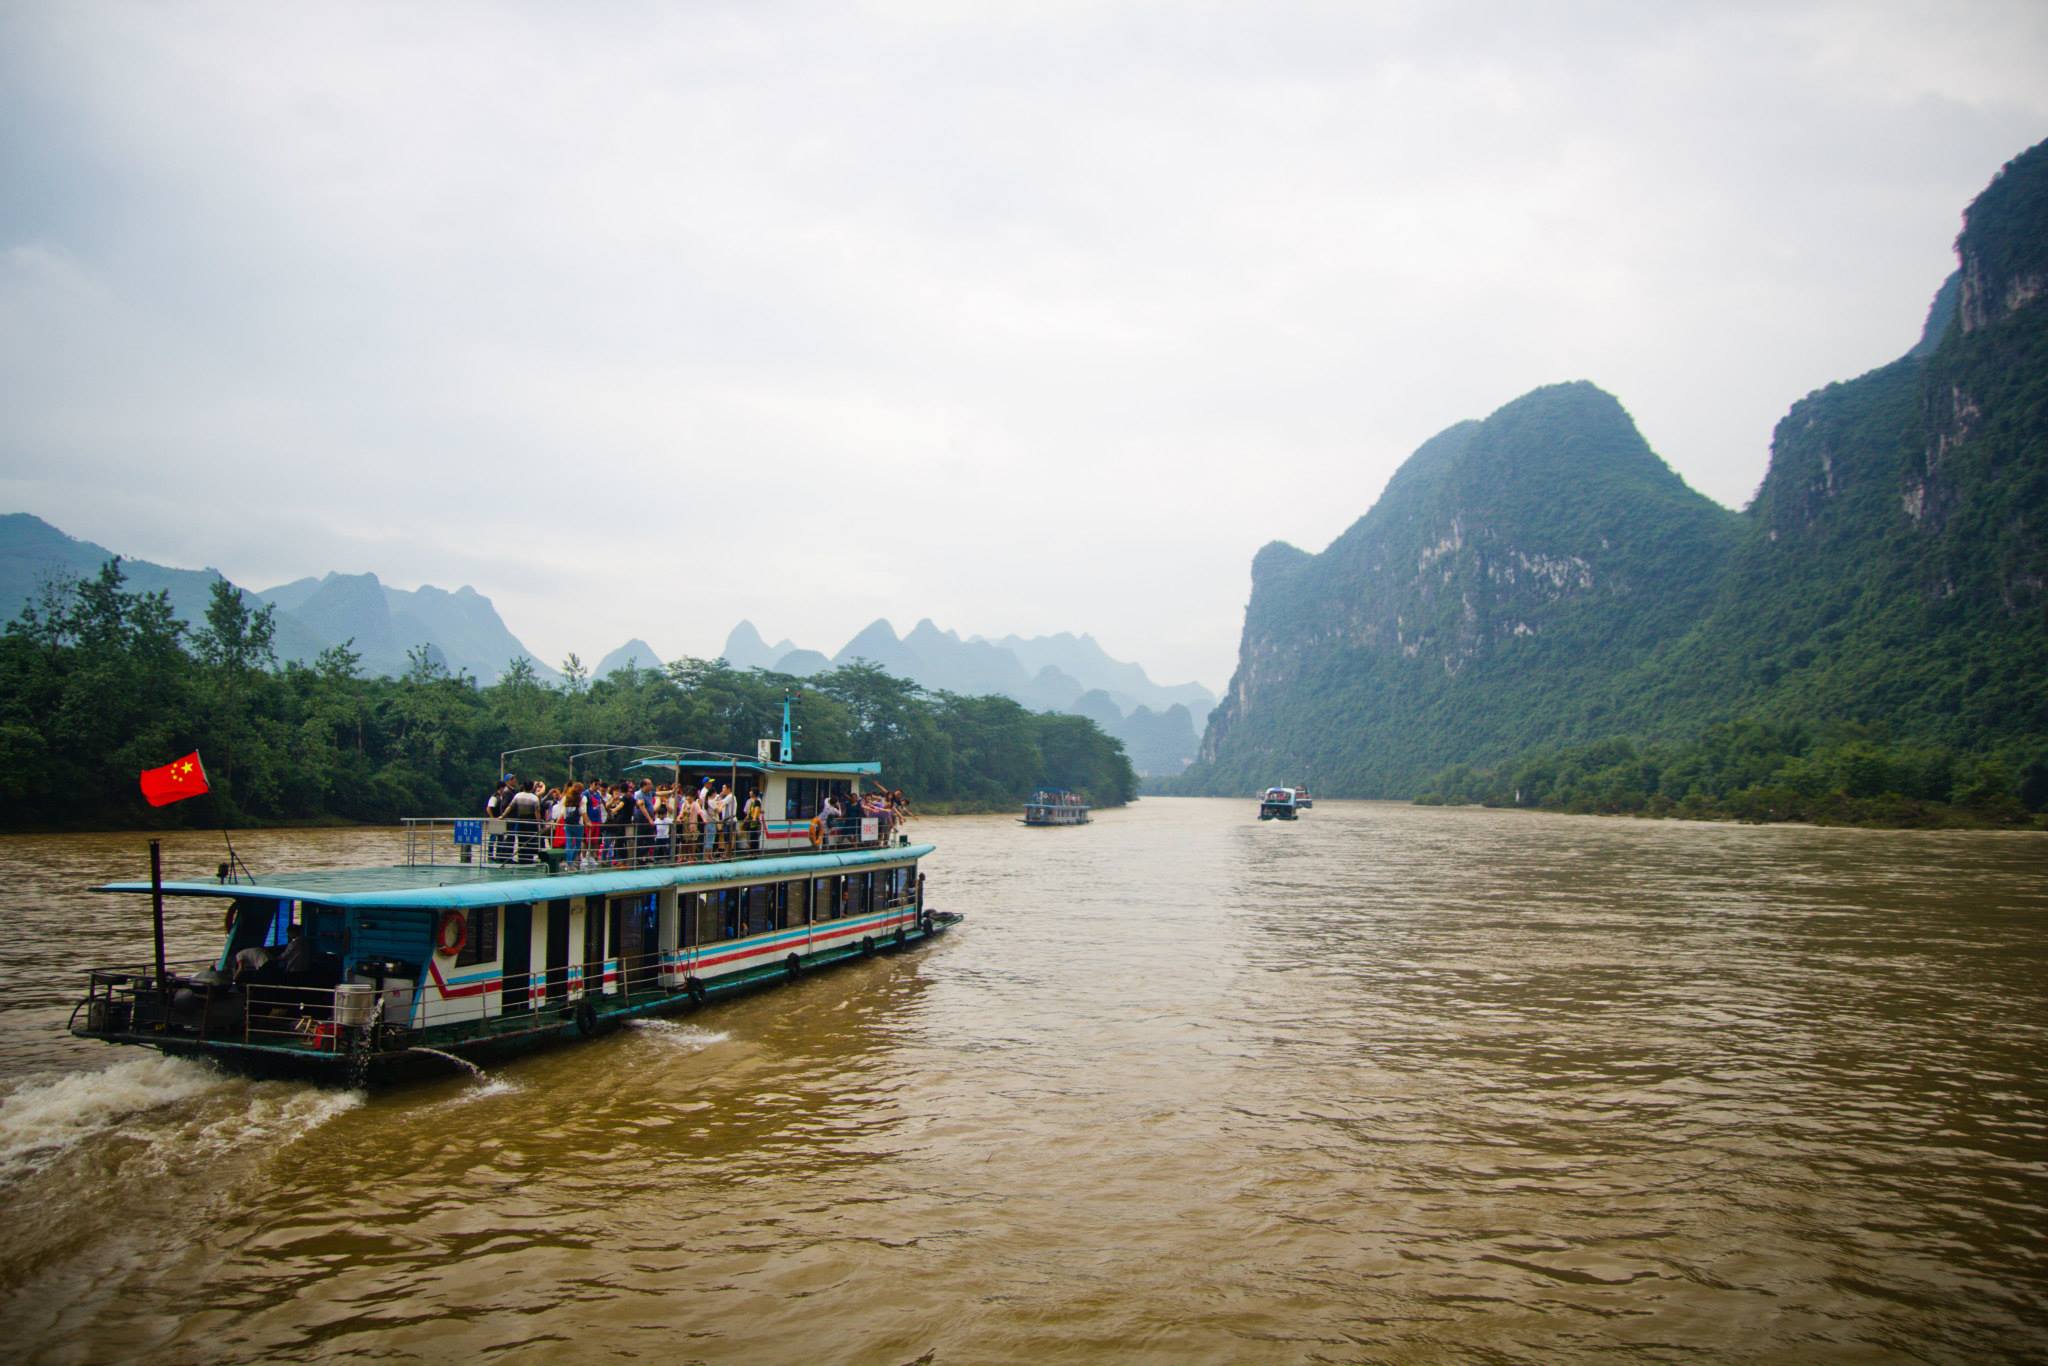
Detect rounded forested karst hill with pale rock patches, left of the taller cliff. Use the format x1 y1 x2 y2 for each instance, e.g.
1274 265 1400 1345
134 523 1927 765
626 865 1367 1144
1188 383 1739 797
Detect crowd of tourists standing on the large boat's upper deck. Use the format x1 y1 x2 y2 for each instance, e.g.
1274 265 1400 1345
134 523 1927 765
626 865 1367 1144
483 774 909 868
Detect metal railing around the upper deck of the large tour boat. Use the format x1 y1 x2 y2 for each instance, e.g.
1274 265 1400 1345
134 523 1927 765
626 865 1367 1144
403 815 903 872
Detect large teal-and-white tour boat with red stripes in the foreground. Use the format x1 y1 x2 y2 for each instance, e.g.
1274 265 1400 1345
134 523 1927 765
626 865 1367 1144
72 715 961 1085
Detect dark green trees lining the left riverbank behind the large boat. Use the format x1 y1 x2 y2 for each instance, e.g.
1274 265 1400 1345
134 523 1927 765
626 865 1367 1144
0 561 1137 829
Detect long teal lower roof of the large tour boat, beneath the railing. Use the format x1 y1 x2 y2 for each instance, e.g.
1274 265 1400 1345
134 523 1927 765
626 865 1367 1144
96 844 936 911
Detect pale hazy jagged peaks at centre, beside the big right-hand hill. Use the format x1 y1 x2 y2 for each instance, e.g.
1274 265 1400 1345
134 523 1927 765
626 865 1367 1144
721 618 1217 776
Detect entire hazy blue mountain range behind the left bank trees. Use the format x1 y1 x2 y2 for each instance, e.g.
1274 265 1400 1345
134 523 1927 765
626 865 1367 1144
0 512 1214 774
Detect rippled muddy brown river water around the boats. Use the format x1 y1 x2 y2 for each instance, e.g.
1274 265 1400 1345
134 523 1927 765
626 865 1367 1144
0 799 2048 1366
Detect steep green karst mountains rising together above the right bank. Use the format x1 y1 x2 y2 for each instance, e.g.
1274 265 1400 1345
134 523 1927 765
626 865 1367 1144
1182 143 2048 797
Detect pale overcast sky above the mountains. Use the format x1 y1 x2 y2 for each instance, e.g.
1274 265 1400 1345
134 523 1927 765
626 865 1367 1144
0 0 2048 688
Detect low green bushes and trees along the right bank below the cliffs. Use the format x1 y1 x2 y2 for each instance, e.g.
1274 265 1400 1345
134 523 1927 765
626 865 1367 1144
1415 721 2048 829
